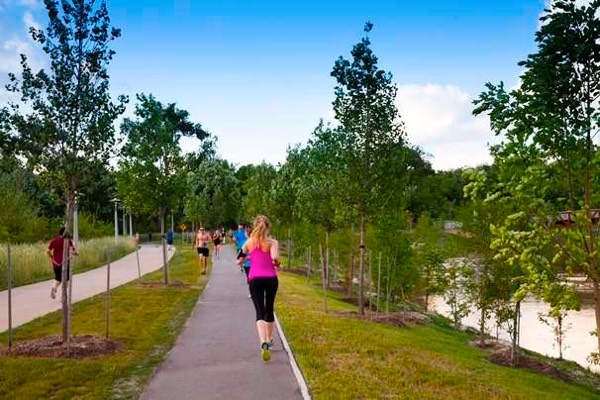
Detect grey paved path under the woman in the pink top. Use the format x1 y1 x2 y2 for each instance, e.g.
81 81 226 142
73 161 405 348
141 246 302 400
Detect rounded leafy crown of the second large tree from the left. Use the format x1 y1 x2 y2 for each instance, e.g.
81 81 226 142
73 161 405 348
117 94 210 234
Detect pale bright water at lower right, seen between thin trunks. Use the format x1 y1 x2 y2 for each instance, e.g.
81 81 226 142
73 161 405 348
432 297 600 371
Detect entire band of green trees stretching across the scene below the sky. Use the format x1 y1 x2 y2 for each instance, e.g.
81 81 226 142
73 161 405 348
0 0 600 357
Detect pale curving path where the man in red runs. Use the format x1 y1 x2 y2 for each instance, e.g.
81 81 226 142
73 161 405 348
0 245 174 332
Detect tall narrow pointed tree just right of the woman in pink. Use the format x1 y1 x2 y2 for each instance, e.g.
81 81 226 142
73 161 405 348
331 22 404 313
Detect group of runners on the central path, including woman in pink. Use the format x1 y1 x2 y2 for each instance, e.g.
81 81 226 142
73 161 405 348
195 215 279 361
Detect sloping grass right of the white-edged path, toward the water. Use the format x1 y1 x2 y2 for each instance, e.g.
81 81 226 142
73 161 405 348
276 273 600 400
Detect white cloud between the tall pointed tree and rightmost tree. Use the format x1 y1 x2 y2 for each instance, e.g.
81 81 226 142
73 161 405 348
397 84 496 170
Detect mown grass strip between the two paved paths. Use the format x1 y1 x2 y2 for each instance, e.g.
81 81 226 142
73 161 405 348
0 246 208 399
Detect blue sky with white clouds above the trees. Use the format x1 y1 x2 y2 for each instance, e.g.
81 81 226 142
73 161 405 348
0 0 564 170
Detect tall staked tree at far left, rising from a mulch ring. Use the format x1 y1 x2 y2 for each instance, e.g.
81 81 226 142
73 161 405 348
7 0 127 342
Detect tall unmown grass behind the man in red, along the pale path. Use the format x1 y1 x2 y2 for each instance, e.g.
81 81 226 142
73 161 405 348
0 237 135 290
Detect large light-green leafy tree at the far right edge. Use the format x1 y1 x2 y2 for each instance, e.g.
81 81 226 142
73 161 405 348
474 0 600 360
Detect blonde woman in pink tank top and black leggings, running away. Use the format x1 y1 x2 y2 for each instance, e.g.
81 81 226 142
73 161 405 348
238 215 279 361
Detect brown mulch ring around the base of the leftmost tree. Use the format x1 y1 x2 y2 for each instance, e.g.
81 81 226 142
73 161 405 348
0 335 122 359
